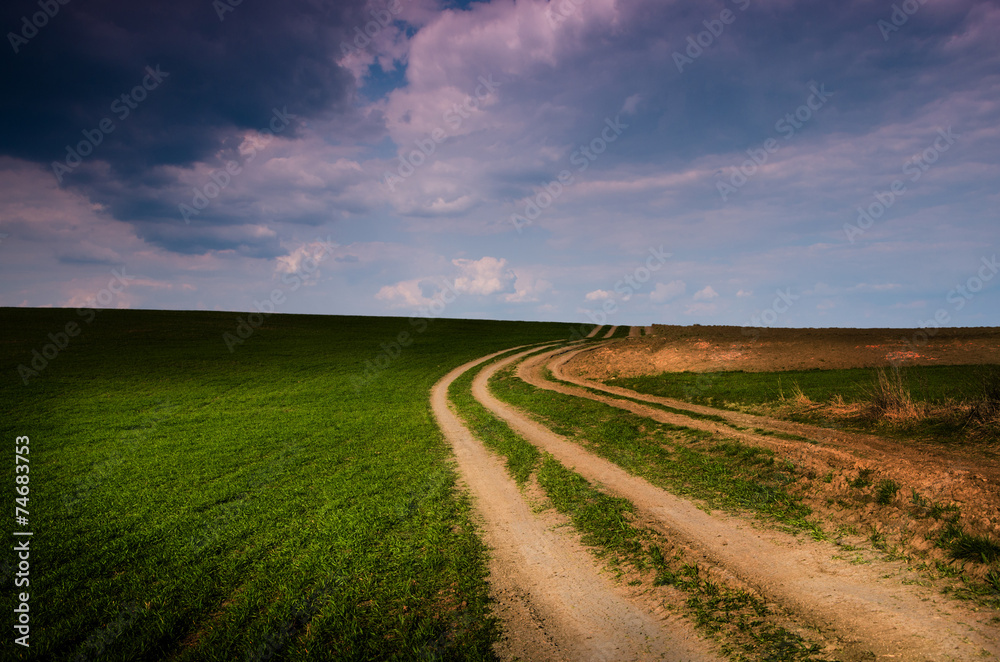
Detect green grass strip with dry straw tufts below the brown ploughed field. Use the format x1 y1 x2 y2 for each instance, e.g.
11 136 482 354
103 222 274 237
607 365 1000 444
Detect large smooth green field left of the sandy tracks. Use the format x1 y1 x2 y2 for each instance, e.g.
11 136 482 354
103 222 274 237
0 309 571 662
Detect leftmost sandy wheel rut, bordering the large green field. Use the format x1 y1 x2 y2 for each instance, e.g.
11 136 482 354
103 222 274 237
431 354 720 661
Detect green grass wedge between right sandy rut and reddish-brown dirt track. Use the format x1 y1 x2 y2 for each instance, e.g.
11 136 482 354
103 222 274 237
491 368 820 535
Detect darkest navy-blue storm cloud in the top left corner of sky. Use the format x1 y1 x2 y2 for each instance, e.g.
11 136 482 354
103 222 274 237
0 0 363 178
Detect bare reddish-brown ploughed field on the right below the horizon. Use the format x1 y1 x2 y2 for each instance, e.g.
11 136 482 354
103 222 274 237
573 324 1000 380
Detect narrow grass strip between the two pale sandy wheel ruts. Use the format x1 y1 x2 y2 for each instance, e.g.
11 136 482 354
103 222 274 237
449 357 819 661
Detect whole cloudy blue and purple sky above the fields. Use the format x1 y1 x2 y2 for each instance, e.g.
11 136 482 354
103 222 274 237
0 0 1000 328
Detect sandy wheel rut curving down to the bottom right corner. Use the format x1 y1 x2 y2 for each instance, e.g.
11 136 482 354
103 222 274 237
473 350 1000 660
